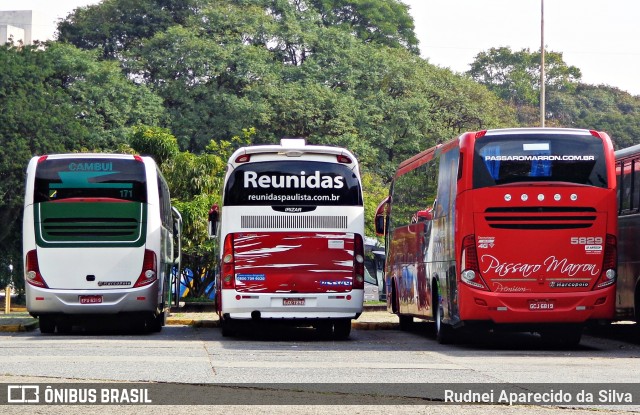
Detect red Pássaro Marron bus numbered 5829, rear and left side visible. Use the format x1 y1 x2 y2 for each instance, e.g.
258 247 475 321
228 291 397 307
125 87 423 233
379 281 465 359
376 128 617 345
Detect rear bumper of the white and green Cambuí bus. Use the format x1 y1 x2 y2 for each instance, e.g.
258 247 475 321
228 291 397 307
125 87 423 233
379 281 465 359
26 281 159 316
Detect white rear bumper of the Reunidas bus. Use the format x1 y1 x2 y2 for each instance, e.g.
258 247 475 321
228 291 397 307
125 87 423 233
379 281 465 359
221 290 364 320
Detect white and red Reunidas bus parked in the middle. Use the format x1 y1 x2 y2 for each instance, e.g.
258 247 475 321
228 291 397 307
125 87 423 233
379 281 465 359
209 139 364 338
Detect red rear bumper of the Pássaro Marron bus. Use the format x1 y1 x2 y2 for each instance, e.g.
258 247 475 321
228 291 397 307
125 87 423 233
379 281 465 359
459 286 615 324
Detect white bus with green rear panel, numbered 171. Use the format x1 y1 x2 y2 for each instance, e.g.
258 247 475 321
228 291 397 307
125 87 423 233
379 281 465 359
23 153 181 333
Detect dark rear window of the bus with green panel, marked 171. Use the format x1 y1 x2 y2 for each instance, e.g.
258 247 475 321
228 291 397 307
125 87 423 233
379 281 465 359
34 158 147 203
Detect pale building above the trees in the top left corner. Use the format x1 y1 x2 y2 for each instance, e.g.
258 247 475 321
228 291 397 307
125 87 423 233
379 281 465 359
0 10 54 45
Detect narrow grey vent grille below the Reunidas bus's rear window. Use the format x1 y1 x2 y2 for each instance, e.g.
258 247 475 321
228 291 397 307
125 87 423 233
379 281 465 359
240 215 347 229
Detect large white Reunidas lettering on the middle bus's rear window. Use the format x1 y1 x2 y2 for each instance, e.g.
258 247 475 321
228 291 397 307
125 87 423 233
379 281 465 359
244 170 344 189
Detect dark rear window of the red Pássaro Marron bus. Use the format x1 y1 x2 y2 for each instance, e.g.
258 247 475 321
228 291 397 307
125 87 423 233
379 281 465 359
473 134 608 188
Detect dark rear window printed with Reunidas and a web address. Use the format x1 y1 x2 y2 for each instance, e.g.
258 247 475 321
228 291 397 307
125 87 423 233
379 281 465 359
224 161 362 206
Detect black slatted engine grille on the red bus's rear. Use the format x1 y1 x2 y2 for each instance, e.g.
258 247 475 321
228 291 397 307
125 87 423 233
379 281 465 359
484 206 596 229
